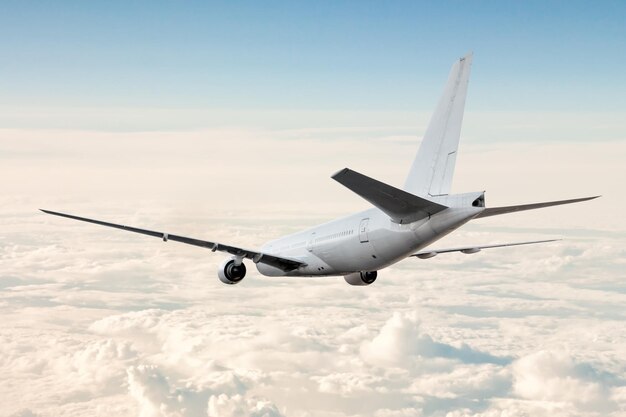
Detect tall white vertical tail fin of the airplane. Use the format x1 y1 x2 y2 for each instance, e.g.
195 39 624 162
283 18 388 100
404 53 472 197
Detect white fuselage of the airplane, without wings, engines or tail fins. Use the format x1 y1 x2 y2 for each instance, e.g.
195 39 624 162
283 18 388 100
256 207 484 277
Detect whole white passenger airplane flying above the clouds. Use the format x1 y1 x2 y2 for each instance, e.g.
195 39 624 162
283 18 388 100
42 54 599 285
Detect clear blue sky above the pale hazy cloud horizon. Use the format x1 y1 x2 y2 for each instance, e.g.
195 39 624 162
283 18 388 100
0 1 626 118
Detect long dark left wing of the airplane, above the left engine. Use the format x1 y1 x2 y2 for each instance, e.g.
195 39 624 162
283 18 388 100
40 209 306 271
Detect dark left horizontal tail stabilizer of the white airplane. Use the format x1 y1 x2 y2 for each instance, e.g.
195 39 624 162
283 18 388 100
332 168 448 224
